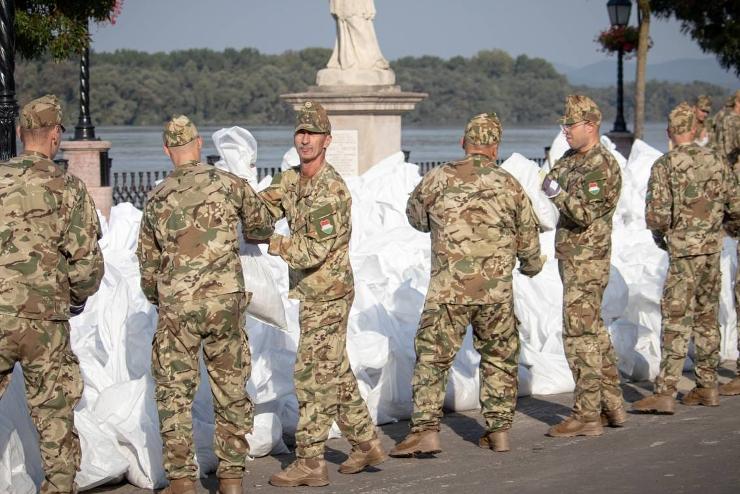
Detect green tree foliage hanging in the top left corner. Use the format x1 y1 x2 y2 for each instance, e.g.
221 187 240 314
15 0 122 61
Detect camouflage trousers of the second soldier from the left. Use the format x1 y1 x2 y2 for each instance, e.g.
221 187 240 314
152 293 252 479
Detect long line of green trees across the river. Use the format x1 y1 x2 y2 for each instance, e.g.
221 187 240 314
16 48 729 126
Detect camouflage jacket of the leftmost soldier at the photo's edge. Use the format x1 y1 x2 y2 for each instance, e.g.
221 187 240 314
0 153 104 320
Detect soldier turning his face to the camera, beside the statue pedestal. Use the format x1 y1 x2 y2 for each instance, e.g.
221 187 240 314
260 101 386 487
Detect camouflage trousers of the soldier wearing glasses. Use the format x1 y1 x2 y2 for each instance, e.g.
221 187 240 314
558 259 624 422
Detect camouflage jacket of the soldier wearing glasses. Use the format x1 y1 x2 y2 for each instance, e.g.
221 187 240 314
547 144 622 261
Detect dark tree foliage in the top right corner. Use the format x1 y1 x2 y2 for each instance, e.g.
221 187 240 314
650 0 740 75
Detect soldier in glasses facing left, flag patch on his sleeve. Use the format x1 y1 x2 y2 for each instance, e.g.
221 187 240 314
543 95 627 437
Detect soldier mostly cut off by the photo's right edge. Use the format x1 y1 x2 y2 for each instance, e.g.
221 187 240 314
719 91 740 396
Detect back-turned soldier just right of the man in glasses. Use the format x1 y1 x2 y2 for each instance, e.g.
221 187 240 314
632 102 734 414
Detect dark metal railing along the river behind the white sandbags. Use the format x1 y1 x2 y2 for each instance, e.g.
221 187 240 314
113 156 546 209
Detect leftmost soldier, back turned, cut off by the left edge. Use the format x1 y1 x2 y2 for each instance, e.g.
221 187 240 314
0 95 103 493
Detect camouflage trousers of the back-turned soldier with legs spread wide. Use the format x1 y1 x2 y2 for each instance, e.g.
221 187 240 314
411 300 519 432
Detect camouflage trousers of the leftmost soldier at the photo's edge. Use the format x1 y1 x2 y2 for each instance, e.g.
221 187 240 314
0 314 82 493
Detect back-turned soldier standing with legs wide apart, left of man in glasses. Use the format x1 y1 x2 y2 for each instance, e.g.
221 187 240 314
391 113 543 456
